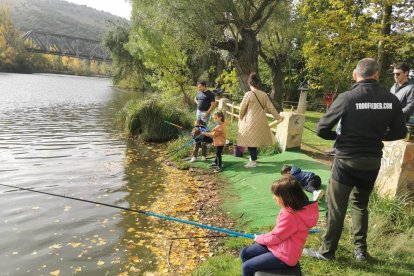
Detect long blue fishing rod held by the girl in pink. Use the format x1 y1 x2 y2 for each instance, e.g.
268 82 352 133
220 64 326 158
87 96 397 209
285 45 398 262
0 183 254 239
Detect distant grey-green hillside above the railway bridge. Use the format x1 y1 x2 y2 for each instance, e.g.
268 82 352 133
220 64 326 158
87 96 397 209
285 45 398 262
0 0 127 40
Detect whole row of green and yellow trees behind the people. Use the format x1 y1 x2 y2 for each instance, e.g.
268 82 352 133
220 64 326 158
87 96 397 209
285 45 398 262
105 0 414 107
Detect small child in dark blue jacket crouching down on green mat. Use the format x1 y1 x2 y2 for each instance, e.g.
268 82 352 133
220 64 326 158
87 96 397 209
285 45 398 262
280 165 324 201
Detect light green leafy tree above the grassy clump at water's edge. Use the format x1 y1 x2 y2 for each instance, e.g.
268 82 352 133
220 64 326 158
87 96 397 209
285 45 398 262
127 3 192 104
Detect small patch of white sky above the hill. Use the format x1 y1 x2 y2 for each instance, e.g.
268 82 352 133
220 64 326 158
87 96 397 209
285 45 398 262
65 0 131 19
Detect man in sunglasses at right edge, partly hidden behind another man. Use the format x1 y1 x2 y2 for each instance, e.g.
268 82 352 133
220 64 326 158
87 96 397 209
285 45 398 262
391 62 414 121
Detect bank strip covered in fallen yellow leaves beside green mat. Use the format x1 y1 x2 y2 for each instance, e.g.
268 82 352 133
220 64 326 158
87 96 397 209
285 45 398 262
143 165 234 275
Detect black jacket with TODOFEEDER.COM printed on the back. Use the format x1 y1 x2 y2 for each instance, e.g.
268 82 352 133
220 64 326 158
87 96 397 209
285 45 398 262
317 79 407 158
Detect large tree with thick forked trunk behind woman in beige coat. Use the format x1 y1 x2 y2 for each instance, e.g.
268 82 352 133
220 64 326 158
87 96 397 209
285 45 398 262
132 0 279 91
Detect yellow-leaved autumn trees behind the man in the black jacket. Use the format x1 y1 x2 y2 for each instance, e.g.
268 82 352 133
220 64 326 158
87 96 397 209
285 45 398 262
301 0 413 95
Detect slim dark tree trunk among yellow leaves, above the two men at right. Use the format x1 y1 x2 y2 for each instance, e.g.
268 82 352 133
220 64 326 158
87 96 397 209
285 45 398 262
378 4 392 79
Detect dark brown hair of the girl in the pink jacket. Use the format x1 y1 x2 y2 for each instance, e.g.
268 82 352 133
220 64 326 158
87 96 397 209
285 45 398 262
271 175 309 211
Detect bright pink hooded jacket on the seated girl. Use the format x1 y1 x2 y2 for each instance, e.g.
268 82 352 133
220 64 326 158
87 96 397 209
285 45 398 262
256 202 319 266
